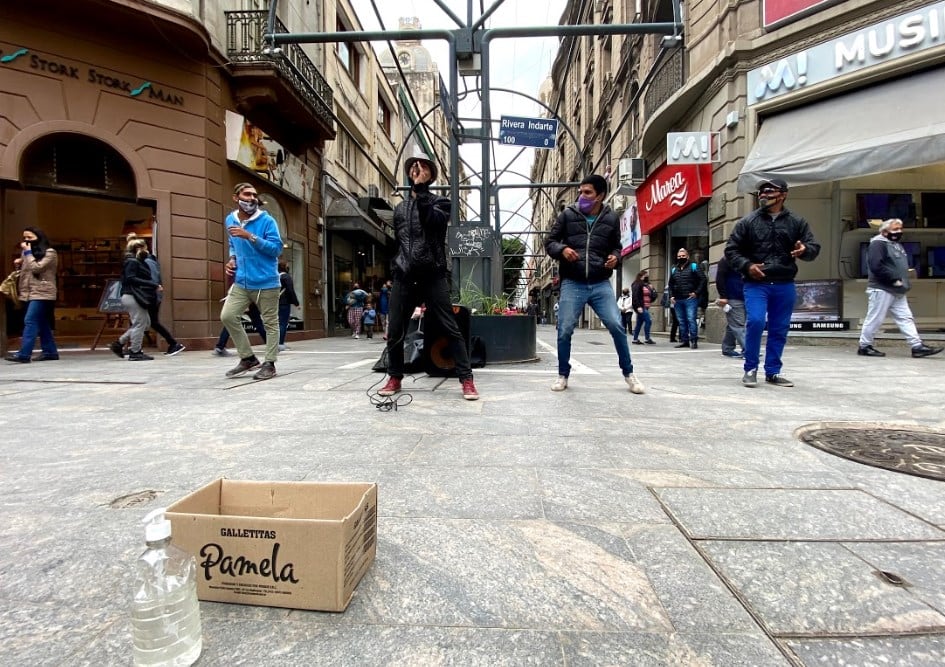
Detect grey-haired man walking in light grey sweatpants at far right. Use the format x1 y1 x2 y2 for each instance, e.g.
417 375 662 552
857 218 943 357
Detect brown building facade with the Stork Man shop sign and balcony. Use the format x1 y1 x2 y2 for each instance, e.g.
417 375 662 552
0 0 336 348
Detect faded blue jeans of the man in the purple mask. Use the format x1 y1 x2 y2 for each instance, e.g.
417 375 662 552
558 278 633 377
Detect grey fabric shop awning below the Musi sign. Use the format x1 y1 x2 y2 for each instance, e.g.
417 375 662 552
738 68 945 192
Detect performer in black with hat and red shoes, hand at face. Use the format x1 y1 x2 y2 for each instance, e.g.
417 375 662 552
378 154 479 401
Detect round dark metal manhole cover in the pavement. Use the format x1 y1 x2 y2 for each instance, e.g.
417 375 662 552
798 426 945 481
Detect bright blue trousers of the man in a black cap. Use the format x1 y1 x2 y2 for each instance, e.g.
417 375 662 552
745 282 797 375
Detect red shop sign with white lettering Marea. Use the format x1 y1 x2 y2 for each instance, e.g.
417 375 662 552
637 164 712 234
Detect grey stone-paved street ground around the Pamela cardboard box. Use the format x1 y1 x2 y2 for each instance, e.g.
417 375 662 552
0 326 945 667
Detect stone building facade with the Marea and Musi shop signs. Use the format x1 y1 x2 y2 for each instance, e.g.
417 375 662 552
533 0 945 338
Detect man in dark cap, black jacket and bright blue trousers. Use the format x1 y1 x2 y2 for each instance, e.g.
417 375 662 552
725 178 820 387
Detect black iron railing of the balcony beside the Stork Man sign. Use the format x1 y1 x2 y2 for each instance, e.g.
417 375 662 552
224 11 334 133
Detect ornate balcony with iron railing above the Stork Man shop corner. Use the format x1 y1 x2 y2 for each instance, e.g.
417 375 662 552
224 11 335 150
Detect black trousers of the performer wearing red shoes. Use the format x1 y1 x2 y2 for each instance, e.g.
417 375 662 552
387 276 472 380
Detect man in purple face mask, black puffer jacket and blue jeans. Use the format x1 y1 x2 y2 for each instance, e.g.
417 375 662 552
545 174 644 394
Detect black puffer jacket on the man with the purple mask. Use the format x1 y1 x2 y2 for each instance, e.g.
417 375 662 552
545 204 622 283
